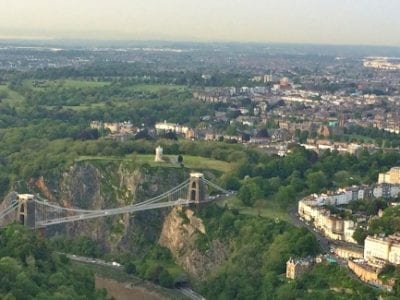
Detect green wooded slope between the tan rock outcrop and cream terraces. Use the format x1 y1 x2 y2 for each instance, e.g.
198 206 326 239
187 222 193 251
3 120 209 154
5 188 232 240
195 206 376 300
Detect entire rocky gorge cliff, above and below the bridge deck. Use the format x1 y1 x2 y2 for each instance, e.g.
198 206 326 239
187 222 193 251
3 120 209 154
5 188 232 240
10 161 227 278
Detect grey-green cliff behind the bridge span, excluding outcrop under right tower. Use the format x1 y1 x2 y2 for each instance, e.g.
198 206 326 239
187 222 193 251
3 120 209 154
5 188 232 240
34 162 188 253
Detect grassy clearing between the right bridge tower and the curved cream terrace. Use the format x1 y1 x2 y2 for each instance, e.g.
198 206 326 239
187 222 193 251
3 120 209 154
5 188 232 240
218 197 291 222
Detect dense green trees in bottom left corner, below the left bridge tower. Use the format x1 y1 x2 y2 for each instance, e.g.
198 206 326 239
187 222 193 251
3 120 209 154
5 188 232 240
0 225 106 300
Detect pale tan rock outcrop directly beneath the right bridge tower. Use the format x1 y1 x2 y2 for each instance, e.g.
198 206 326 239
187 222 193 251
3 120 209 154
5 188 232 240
159 207 227 278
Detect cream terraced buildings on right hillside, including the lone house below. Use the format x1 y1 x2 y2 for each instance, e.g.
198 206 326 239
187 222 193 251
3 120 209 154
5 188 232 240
287 167 400 290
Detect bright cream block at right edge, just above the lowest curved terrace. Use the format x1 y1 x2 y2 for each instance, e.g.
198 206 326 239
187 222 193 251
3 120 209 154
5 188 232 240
364 235 400 265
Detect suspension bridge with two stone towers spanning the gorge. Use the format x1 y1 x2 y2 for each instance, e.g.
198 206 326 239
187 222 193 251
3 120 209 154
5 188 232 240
0 173 232 228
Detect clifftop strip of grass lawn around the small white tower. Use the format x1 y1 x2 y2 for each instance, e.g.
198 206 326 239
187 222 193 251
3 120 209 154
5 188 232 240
76 154 234 173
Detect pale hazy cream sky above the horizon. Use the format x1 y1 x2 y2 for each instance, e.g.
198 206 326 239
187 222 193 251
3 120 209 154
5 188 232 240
0 0 400 46
